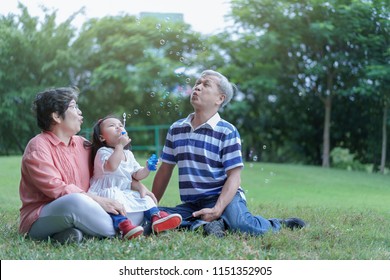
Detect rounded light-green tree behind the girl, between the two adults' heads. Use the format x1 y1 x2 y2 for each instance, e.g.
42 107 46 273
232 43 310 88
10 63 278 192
73 15 206 128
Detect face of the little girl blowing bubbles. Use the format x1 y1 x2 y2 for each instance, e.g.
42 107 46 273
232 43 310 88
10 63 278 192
100 118 127 147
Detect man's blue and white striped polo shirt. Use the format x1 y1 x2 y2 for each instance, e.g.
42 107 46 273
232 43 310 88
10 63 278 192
161 113 243 202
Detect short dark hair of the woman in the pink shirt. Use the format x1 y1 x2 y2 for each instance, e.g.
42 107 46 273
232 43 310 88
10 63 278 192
33 87 79 131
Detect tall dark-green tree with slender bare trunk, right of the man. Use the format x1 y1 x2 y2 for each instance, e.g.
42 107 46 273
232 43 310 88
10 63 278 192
232 0 386 167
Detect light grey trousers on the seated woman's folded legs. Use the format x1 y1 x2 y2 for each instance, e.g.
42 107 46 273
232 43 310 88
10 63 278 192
29 193 115 240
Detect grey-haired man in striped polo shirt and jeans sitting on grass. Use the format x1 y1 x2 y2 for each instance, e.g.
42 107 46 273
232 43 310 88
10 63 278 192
152 70 305 237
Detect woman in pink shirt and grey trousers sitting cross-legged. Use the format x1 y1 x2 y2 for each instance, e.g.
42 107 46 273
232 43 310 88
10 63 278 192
19 88 149 243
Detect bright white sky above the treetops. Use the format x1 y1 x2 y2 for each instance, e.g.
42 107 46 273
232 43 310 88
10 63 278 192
0 0 230 34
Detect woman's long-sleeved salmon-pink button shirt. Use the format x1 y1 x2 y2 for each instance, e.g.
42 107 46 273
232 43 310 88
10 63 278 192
19 132 91 233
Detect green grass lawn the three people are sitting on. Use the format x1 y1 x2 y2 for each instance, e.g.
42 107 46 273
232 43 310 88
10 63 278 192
0 157 390 260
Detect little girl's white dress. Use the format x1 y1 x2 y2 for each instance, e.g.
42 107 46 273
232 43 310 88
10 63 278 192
88 147 156 213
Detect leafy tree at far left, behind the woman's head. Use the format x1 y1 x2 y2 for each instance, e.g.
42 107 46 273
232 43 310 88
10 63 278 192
0 4 75 154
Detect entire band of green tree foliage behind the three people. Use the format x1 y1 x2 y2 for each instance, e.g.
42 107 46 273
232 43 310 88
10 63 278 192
0 0 390 170
